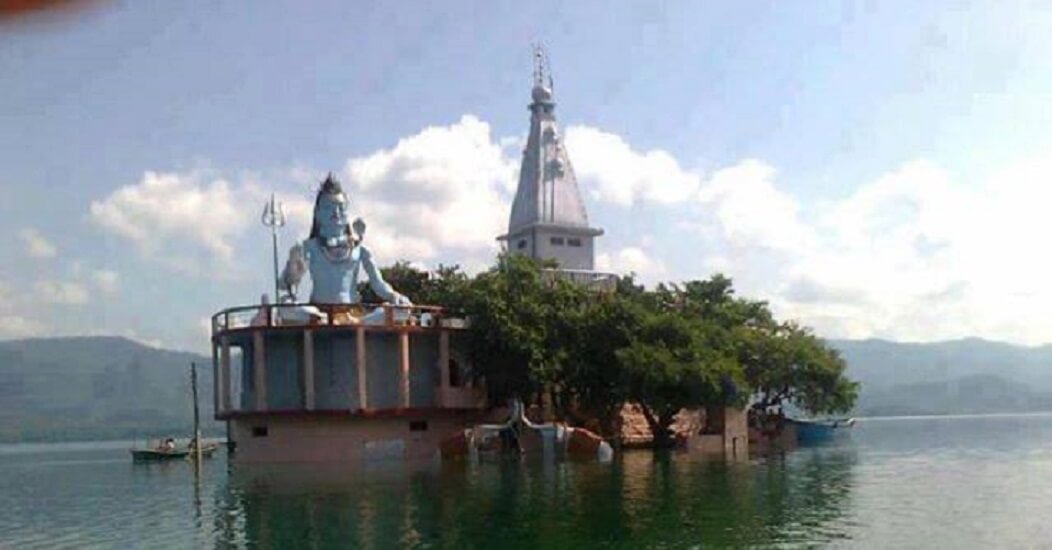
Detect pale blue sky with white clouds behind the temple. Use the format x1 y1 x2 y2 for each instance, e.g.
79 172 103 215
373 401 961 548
0 2 1052 349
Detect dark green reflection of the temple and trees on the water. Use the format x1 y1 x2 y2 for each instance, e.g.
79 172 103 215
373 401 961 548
221 448 857 548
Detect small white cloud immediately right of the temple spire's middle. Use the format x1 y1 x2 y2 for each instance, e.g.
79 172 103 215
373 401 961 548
566 126 701 206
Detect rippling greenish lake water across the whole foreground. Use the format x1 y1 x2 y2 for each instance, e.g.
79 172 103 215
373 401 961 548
0 415 1052 549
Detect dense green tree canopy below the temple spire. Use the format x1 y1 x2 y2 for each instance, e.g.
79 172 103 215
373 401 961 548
376 260 857 440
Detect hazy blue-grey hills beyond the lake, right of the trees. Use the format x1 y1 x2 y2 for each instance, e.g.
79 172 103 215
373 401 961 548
829 339 1052 415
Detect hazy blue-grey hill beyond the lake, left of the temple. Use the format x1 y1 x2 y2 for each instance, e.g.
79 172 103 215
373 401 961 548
0 337 219 442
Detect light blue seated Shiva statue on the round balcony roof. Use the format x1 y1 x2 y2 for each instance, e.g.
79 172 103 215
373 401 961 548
281 174 412 306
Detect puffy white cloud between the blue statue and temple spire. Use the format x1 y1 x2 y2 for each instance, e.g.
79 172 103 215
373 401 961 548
344 116 518 267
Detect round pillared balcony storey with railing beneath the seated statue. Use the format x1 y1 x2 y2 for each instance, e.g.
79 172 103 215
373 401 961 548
211 304 485 420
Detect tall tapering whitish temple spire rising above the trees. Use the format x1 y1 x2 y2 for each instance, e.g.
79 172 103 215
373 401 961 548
500 47 603 271
